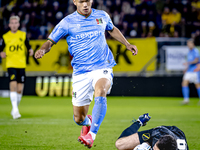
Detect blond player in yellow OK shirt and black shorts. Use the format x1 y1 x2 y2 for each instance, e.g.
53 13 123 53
0 16 33 119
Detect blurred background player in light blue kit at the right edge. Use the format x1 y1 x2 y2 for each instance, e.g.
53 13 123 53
182 39 200 104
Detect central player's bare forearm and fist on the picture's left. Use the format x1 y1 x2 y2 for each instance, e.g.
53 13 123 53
35 40 54 59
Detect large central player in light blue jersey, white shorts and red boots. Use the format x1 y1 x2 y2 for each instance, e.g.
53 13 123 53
35 0 137 148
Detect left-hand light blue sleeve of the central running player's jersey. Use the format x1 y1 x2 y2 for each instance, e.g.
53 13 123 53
48 19 68 44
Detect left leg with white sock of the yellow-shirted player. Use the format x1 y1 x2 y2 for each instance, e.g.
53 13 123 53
10 81 21 119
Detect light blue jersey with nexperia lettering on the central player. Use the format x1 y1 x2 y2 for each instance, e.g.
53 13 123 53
48 9 116 75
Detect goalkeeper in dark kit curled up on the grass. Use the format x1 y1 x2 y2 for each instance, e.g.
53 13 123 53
115 113 189 150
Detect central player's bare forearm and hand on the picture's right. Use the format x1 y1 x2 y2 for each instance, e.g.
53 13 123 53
108 27 138 55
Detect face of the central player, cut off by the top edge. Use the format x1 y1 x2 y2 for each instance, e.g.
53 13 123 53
73 0 93 15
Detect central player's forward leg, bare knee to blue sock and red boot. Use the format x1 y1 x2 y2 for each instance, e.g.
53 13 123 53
79 78 111 148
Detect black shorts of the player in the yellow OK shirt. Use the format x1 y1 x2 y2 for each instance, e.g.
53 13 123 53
7 68 26 83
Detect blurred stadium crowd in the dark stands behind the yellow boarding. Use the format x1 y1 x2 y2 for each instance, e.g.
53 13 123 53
0 0 200 42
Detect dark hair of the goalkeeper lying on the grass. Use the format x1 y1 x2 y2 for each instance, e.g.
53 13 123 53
156 135 177 150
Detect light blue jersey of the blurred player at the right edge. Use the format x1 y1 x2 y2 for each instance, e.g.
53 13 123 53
187 48 199 72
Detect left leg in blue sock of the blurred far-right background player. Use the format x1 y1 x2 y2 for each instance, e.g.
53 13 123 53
182 80 190 105
